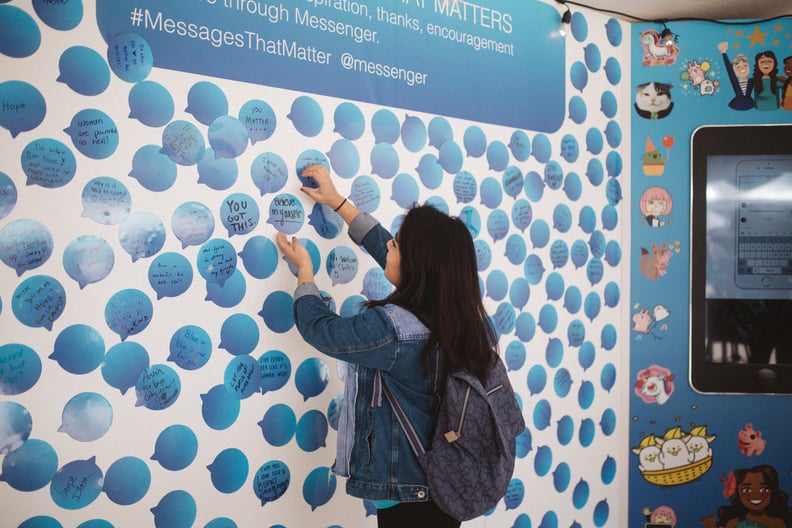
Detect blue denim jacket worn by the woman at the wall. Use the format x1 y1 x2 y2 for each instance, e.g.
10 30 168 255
294 213 444 502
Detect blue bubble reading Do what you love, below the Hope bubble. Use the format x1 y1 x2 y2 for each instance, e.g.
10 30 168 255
21 138 77 189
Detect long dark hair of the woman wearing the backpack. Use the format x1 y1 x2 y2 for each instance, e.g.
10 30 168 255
368 205 497 382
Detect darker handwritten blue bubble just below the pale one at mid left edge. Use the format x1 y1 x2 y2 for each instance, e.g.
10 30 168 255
11 275 66 330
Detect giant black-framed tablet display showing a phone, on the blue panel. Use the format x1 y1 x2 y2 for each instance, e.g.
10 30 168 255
690 125 792 393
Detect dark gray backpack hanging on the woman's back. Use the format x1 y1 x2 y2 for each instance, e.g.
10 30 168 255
382 358 525 521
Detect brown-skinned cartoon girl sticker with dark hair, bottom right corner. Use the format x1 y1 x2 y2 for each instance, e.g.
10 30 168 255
701 464 792 528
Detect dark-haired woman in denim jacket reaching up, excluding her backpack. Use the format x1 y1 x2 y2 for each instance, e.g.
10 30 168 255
277 165 497 528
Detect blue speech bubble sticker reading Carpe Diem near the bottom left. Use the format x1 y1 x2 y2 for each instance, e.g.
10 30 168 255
50 457 104 510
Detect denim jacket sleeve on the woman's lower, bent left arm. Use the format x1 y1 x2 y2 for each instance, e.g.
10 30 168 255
294 282 396 370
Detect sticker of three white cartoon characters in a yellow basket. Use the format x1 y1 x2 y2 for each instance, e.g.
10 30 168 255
632 425 716 486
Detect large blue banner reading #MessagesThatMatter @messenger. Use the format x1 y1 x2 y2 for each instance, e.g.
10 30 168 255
96 0 568 132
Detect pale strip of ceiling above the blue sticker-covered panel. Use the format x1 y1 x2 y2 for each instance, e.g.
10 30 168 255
572 0 792 22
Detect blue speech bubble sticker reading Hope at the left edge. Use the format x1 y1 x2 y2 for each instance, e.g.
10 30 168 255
0 80 47 138
